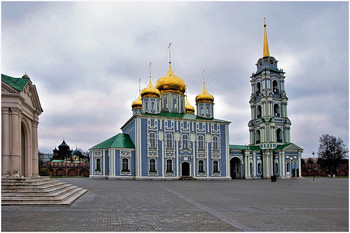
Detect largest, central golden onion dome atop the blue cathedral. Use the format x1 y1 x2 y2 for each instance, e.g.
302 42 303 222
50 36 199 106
156 64 186 94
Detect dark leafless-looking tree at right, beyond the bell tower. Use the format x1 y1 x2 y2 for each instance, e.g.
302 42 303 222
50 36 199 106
317 134 348 175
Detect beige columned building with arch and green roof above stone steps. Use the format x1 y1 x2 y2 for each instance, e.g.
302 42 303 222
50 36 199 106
1 74 43 177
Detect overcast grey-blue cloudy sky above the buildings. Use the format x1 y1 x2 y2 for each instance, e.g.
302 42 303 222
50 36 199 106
1 2 349 157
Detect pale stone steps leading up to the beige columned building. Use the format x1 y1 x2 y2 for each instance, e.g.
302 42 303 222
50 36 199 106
1 177 87 205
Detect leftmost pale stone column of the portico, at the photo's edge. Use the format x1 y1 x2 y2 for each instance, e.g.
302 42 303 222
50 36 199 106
1 108 10 175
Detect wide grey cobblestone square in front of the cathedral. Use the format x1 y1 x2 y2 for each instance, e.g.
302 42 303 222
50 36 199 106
1 178 349 231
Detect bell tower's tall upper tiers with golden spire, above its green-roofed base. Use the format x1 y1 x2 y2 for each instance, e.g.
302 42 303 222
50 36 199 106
248 22 291 149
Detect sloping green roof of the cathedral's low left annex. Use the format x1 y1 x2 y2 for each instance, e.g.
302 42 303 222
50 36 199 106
90 133 135 150
